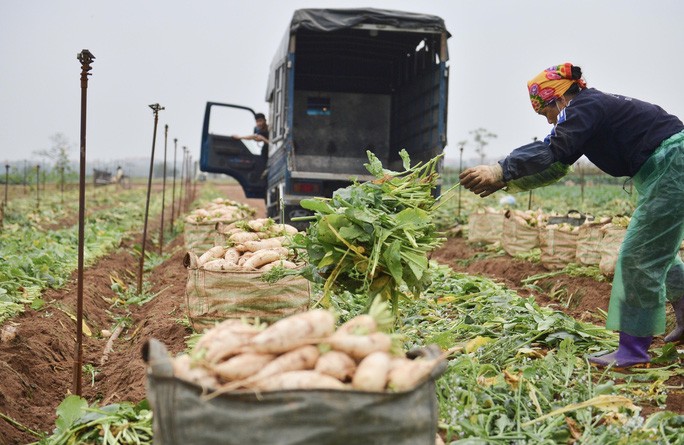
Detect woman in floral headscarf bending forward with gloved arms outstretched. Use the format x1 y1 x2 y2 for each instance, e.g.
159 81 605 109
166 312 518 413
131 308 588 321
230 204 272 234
460 63 684 367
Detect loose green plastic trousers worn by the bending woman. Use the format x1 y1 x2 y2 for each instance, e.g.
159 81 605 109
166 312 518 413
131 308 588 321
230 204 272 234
606 131 684 337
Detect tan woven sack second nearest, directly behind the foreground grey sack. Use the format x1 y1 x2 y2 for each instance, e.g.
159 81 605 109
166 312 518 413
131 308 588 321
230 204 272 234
185 268 310 331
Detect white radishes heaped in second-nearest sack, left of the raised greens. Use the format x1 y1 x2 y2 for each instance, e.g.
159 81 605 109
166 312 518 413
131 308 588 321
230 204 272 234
184 218 299 272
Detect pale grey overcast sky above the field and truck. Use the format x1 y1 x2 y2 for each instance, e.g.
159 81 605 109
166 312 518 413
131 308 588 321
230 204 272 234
0 0 684 166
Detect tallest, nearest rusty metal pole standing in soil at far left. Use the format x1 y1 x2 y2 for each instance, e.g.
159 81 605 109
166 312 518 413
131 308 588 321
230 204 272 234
72 49 95 396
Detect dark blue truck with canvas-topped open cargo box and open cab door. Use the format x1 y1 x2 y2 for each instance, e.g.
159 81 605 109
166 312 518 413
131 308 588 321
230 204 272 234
199 8 450 223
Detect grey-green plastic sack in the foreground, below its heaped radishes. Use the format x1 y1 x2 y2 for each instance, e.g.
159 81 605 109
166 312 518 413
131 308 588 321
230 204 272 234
143 339 446 445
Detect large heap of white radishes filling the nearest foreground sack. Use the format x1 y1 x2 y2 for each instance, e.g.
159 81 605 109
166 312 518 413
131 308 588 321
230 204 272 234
174 309 444 397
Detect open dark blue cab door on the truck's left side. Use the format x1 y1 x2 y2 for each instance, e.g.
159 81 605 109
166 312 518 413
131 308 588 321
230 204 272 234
200 102 268 198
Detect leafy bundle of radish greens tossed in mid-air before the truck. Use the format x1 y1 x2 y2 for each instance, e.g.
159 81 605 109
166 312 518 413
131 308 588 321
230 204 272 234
299 150 444 312
